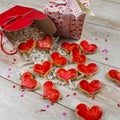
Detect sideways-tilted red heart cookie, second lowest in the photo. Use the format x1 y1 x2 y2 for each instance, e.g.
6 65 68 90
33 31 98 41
43 81 61 104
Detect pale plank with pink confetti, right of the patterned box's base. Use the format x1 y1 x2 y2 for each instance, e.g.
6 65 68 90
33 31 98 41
81 23 120 68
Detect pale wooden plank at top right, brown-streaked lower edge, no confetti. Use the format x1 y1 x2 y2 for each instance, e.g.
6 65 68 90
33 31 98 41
86 0 120 30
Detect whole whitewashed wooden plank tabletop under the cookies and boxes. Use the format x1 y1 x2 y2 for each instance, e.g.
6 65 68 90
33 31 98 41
0 0 120 120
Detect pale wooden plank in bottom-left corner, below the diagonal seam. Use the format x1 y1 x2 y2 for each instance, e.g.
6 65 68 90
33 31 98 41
0 78 76 120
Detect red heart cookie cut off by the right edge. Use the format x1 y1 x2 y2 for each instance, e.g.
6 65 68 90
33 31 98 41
107 69 120 84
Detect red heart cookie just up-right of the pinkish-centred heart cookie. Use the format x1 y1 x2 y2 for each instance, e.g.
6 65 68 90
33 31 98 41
77 63 98 78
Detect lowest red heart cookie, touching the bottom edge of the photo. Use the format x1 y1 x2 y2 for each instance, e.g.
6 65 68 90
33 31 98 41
75 104 102 120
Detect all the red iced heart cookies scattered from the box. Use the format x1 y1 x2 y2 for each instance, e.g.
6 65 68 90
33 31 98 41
18 36 120 120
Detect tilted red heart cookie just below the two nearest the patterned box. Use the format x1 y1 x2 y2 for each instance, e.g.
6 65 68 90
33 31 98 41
71 47 87 63
